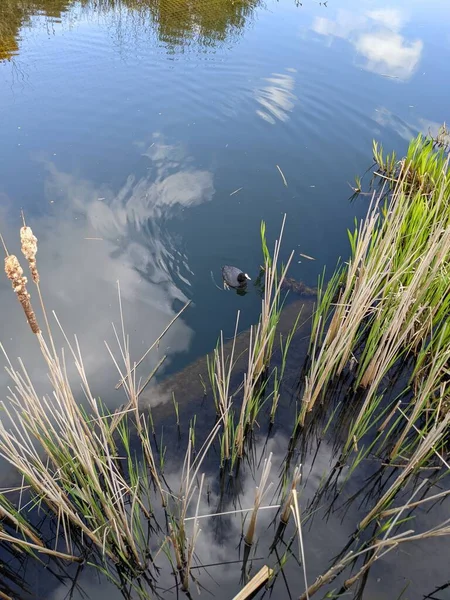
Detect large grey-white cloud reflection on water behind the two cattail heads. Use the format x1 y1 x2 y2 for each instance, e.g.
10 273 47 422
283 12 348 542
0 135 214 406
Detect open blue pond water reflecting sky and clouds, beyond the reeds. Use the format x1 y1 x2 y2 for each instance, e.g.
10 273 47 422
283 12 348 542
0 0 450 599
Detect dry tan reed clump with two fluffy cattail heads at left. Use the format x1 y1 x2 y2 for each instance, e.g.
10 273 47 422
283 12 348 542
0 218 189 591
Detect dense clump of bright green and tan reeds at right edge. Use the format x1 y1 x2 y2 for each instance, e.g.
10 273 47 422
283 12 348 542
297 136 450 464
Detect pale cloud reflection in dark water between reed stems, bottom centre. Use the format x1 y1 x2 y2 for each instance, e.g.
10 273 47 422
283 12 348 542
46 432 344 600
